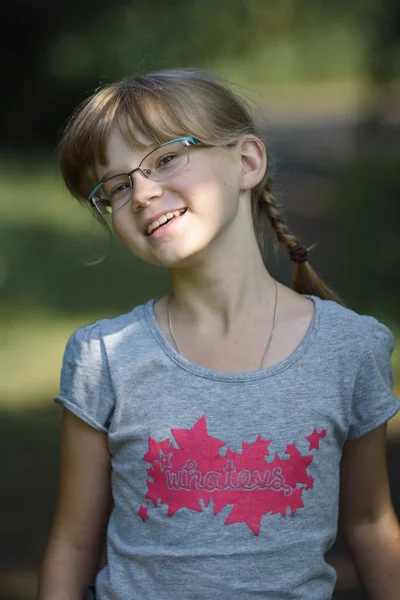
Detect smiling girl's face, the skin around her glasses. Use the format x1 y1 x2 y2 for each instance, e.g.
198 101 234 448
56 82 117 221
98 129 256 268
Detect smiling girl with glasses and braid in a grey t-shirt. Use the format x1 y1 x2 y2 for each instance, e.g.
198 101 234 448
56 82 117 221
39 70 400 600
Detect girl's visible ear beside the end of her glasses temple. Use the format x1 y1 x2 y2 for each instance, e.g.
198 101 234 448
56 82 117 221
237 136 267 190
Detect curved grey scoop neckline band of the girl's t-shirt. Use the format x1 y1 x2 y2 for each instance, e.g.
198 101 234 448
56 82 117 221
143 294 321 382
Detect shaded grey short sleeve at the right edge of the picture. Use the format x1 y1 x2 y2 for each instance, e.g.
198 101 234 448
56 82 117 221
347 317 400 440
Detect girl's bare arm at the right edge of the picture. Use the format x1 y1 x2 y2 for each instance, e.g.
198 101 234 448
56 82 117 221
339 424 400 600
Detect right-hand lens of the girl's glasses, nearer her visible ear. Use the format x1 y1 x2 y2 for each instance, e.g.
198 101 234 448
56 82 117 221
141 142 189 181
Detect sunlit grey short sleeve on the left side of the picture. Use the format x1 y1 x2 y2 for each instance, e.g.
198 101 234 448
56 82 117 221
54 323 115 432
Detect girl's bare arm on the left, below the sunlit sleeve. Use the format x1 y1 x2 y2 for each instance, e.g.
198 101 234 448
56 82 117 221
38 409 111 600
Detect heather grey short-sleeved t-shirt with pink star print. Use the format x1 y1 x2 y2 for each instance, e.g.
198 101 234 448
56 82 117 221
55 295 400 600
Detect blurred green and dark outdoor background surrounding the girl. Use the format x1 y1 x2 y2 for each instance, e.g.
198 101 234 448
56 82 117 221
0 0 400 600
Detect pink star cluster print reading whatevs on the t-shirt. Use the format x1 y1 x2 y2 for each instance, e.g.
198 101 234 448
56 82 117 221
139 415 327 535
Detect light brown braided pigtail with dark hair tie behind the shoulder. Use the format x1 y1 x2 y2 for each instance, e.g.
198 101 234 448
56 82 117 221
257 179 344 306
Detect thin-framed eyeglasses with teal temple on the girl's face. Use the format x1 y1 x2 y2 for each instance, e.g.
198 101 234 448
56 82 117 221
88 136 201 215
